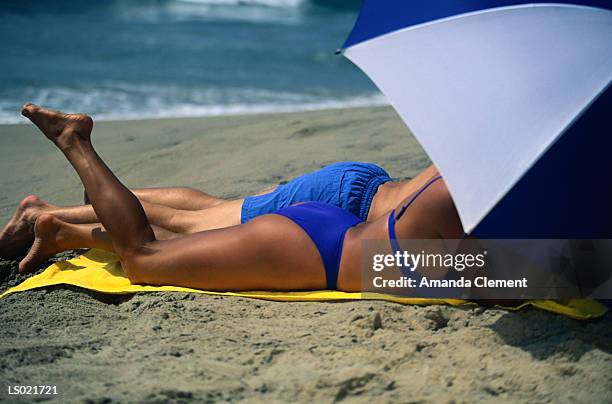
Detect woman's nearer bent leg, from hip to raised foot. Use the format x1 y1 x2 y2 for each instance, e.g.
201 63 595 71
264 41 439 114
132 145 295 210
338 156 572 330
23 104 325 290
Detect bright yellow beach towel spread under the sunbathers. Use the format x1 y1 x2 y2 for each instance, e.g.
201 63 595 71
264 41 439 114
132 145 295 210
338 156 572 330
0 250 608 320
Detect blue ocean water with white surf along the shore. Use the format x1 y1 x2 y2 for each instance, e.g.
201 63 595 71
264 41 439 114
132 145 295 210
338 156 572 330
0 0 385 123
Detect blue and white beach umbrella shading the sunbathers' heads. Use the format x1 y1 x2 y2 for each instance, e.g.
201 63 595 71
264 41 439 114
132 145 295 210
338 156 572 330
340 0 612 238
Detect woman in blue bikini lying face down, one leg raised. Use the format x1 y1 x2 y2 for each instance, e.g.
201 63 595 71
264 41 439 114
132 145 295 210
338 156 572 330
11 104 462 291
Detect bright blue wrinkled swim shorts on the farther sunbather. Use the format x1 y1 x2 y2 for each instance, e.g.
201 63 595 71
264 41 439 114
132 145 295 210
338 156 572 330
240 162 391 223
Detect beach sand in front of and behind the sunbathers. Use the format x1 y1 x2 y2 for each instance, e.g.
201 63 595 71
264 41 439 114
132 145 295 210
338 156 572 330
0 108 612 403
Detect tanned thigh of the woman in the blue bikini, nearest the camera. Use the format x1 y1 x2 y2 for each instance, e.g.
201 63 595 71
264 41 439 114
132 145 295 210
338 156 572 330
128 215 326 291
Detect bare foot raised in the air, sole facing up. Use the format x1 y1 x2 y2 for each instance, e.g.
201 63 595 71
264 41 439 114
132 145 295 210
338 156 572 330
21 104 93 149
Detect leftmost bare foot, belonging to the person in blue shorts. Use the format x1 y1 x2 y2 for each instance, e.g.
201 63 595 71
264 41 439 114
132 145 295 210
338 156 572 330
0 195 54 258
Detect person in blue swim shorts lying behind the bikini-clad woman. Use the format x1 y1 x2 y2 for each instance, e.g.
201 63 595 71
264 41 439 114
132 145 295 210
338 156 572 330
0 152 439 259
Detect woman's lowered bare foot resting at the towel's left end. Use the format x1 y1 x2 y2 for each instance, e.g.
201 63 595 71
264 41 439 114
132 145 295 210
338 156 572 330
19 214 64 273
